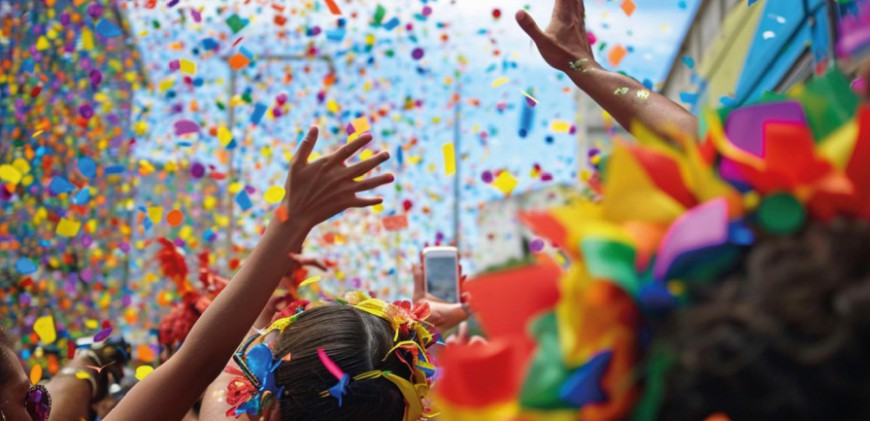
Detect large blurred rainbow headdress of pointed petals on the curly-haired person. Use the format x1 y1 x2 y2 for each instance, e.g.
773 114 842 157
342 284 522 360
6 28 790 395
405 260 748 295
436 67 870 421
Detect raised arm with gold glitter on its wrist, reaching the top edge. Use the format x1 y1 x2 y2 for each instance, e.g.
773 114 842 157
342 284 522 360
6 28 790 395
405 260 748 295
516 0 698 137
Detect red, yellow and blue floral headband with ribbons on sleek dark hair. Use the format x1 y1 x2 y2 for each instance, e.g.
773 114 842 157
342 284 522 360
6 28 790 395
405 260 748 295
227 292 438 421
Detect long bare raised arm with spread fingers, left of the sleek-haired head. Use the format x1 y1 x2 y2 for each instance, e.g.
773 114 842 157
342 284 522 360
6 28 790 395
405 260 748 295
106 128 393 421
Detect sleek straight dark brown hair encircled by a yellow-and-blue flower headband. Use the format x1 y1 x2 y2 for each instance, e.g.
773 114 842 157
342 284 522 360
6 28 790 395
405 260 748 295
275 305 412 421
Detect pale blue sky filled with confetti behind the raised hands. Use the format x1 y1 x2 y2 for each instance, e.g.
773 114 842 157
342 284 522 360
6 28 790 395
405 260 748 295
131 0 697 294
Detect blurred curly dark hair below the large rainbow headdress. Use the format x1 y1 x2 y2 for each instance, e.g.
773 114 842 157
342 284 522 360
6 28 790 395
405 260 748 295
660 219 870 421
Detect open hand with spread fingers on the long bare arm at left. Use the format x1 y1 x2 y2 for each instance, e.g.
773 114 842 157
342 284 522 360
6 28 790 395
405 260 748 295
284 127 394 229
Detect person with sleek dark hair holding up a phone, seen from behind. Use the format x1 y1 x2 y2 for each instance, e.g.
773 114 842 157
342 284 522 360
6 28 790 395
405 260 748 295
201 251 470 421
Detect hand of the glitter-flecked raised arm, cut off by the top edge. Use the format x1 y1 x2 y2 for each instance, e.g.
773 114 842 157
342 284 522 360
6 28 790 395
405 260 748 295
516 0 597 71
